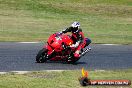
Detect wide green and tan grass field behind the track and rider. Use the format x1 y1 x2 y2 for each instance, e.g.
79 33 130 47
0 0 132 44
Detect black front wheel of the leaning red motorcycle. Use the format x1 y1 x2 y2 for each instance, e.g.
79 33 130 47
36 48 47 63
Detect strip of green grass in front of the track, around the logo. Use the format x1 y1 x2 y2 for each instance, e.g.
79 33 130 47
0 69 132 88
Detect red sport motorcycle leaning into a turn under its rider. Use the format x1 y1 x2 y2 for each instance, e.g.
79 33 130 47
36 33 90 63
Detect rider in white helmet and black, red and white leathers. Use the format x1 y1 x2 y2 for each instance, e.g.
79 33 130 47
59 21 91 61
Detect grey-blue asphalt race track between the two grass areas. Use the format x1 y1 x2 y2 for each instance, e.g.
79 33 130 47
0 42 132 72
